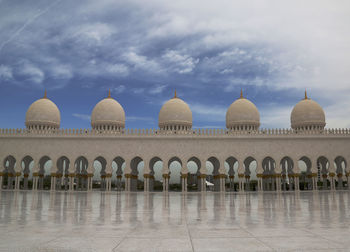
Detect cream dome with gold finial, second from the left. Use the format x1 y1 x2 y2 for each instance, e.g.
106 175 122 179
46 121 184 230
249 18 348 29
91 92 125 129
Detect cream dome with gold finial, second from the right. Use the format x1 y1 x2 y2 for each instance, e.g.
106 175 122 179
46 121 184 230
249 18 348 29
226 91 260 129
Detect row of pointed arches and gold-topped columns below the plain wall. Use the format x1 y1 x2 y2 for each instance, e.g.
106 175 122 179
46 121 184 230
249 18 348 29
0 155 350 192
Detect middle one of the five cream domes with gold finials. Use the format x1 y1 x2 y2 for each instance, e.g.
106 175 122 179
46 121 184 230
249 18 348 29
158 91 192 129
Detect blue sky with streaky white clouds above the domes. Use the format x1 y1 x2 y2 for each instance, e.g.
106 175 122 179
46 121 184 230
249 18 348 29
0 0 350 128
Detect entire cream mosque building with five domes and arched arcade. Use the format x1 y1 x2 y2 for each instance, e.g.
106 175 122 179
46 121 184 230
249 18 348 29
0 89 350 192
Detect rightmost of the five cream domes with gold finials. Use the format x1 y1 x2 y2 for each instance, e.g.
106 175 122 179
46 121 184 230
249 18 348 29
290 92 326 129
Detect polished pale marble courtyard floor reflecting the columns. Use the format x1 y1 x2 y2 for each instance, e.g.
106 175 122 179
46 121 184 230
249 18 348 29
0 191 350 251
